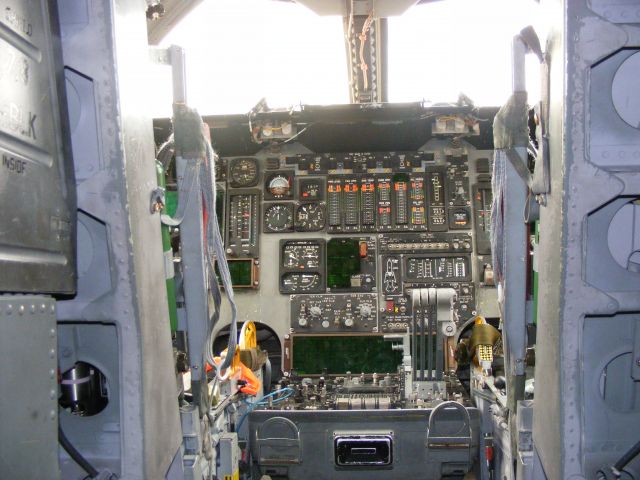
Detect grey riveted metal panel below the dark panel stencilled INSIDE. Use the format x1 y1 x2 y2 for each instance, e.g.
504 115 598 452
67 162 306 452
0 295 59 480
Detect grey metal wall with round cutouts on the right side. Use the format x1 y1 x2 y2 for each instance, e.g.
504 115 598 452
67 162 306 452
533 0 640 480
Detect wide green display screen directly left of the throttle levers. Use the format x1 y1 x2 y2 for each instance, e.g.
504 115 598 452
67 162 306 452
292 335 402 375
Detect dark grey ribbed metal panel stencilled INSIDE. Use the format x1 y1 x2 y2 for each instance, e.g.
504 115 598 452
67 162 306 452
0 0 76 293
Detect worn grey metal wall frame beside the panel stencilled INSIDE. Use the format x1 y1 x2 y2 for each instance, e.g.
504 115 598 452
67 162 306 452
58 0 181 479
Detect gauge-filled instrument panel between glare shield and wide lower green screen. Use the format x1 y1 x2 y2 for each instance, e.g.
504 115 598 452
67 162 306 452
223 145 495 334
